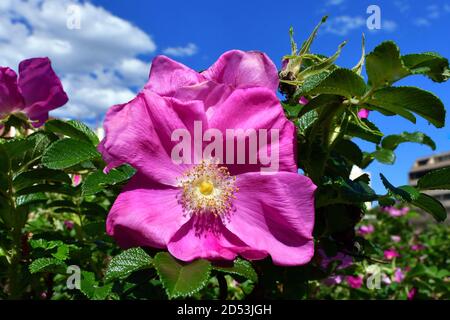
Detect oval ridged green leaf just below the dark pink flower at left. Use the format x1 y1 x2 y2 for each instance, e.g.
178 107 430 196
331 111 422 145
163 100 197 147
42 138 100 169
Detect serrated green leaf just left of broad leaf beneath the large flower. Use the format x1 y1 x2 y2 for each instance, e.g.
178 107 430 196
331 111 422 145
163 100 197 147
105 248 152 282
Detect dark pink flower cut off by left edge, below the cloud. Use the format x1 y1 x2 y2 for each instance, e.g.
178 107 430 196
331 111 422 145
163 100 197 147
0 58 68 127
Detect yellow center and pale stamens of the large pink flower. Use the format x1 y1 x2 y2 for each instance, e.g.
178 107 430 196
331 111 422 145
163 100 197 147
178 161 238 216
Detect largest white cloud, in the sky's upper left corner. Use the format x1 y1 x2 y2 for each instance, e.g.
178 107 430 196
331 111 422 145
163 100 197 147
0 0 156 120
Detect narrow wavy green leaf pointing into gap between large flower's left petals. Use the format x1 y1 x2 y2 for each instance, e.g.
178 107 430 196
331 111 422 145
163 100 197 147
82 165 136 196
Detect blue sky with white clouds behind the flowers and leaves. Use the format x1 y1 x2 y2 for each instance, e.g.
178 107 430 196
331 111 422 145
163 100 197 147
0 0 450 192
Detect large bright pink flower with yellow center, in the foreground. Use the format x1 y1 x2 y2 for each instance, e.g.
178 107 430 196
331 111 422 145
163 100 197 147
99 50 316 265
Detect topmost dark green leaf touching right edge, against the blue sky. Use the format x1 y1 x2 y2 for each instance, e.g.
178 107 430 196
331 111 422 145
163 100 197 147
402 52 449 82
